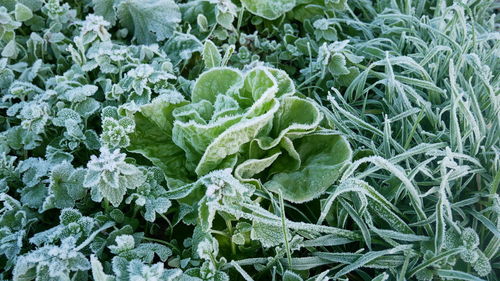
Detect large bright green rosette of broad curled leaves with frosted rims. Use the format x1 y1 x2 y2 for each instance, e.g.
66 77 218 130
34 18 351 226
128 67 351 203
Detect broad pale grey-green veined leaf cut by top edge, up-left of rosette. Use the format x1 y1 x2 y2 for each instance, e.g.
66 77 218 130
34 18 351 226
117 0 181 44
